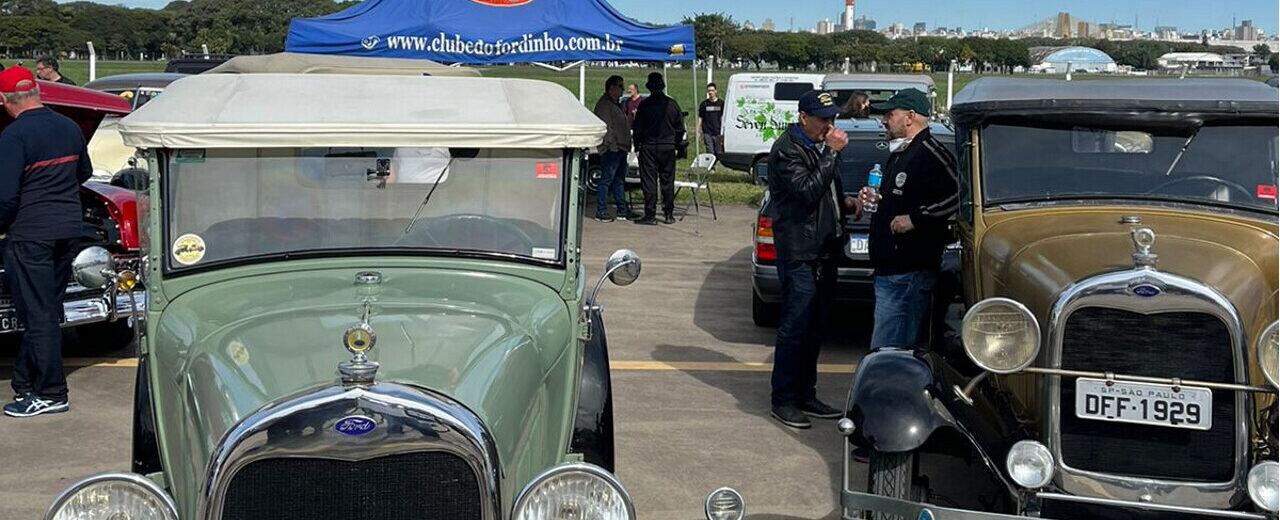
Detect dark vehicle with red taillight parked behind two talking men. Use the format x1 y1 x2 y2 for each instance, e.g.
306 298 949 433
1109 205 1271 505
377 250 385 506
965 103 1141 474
751 119 955 327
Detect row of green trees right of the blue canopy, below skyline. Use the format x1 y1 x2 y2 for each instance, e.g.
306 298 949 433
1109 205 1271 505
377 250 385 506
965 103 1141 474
684 13 1274 72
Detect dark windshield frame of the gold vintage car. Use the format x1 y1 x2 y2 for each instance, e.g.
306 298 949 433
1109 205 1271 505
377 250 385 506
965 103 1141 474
966 118 1280 218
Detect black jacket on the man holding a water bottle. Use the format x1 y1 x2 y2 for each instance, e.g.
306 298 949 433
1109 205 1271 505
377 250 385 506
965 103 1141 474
870 128 960 275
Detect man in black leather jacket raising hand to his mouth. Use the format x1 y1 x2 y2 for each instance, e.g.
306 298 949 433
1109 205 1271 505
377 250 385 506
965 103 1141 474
768 91 859 428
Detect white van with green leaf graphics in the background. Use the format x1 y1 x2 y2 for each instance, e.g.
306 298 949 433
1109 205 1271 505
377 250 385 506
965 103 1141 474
719 72 823 172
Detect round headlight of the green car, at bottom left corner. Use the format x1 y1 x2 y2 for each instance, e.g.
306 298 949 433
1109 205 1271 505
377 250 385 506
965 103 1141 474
45 473 178 520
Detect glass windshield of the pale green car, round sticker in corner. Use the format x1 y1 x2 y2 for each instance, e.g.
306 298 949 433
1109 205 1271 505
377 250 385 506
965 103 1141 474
165 149 568 269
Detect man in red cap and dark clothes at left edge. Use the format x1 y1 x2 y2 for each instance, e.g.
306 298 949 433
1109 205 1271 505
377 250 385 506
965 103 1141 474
0 65 93 418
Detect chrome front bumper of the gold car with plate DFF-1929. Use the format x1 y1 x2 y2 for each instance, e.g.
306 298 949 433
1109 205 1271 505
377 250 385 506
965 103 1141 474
840 489 1272 520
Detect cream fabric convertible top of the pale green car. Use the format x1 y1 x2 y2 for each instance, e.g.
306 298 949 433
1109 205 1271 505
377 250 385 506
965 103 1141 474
119 74 604 149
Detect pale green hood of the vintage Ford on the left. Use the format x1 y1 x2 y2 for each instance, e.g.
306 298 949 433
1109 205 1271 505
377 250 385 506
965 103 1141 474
148 269 577 514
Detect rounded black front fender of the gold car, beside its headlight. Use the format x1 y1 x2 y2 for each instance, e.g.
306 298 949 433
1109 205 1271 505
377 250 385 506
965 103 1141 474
845 350 954 453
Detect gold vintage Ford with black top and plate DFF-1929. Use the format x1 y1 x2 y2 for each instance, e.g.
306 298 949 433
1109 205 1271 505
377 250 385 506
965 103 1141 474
840 78 1280 520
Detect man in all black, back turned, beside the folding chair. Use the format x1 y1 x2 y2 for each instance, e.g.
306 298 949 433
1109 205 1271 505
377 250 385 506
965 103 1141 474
632 72 685 225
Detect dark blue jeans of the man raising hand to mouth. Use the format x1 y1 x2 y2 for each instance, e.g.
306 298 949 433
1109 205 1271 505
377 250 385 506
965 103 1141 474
771 259 836 406
